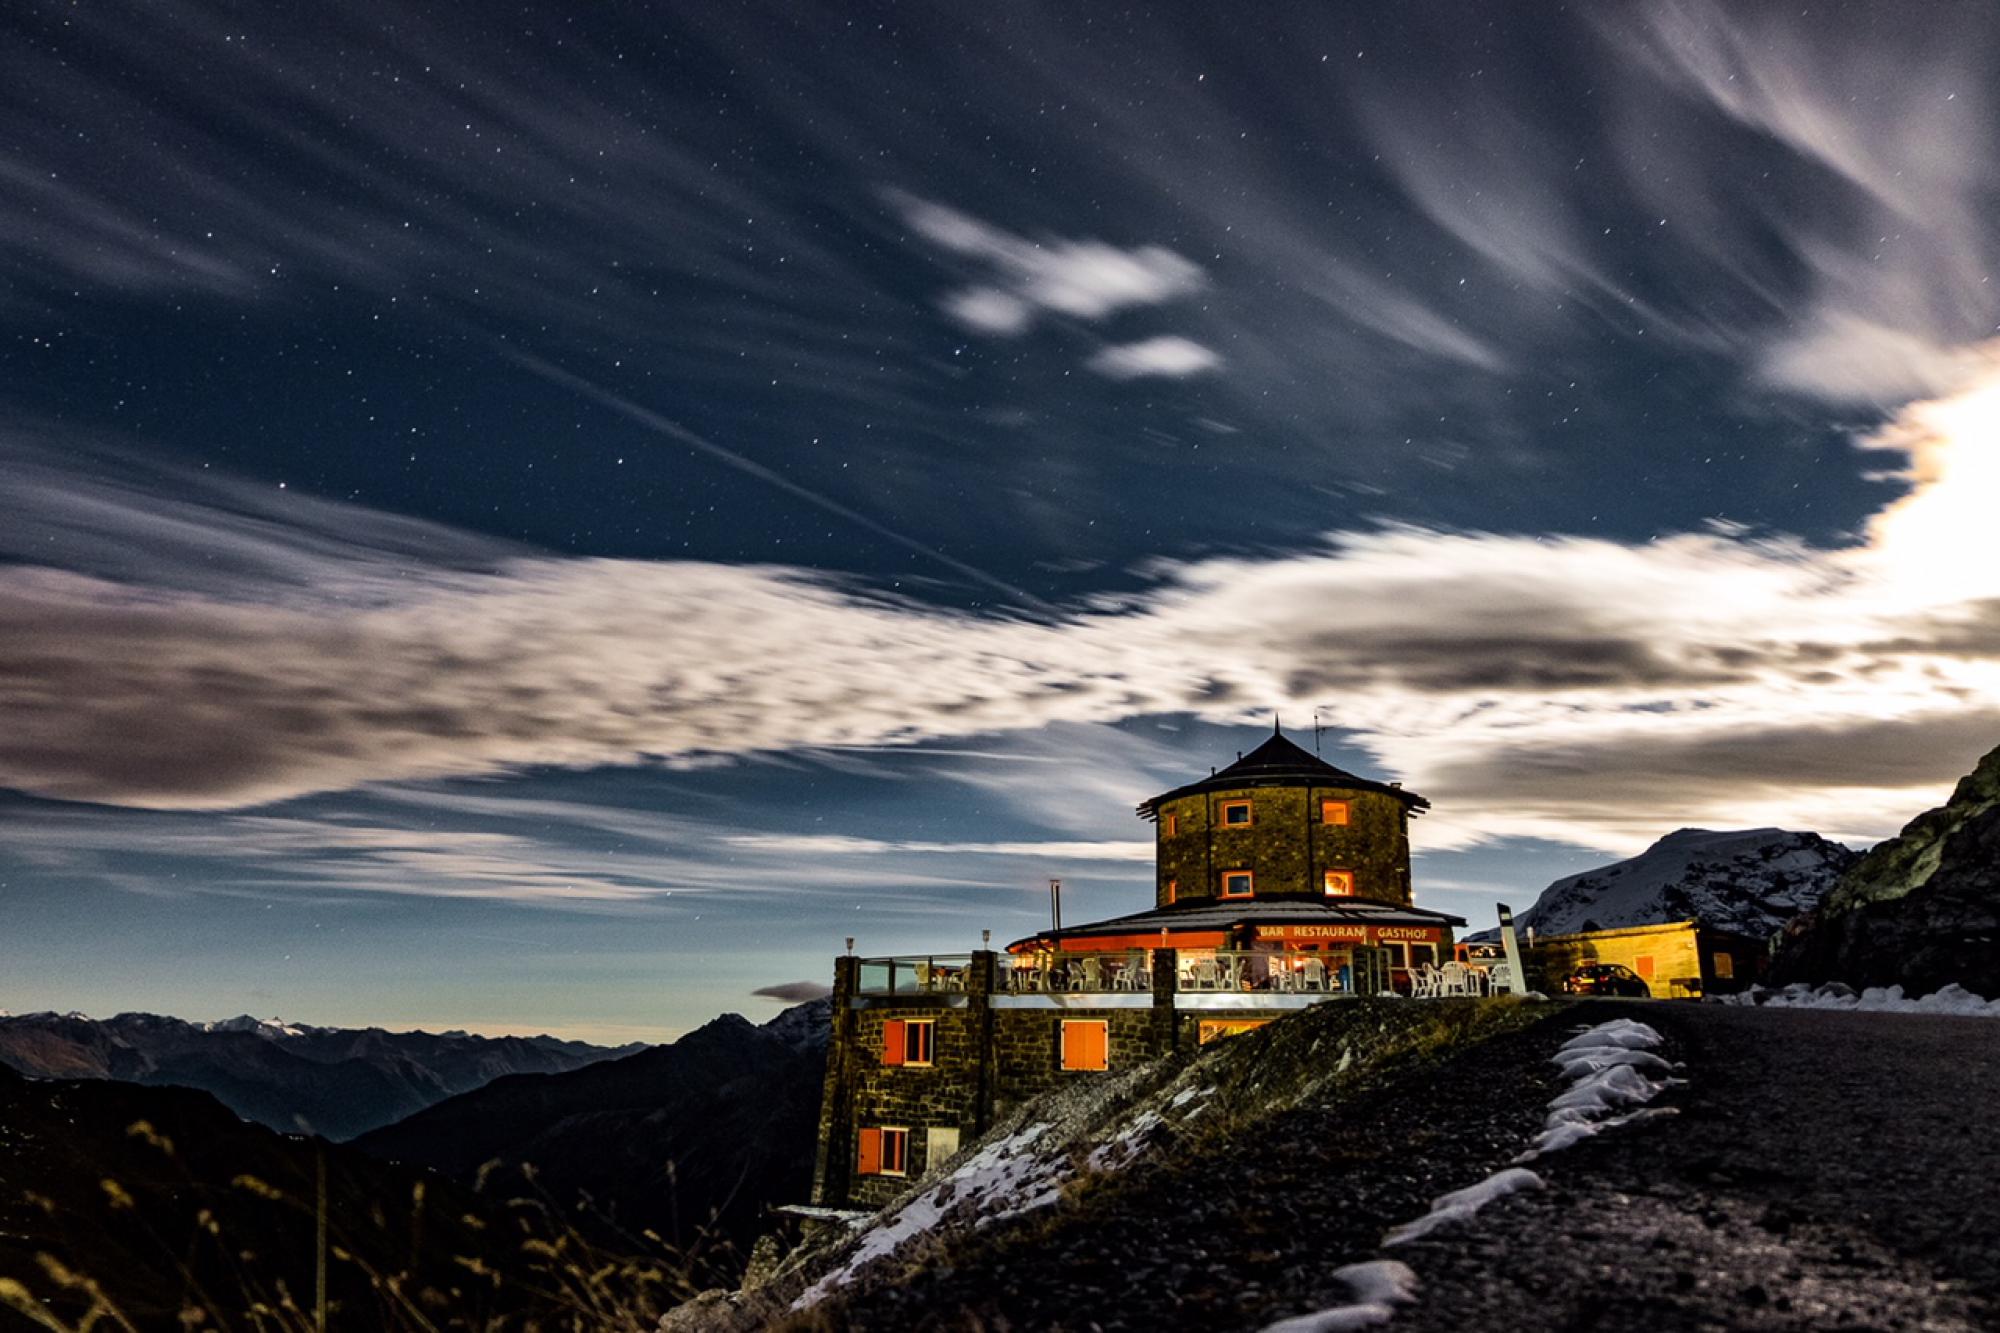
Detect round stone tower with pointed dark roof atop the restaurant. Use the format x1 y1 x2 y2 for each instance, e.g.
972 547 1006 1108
1138 729 1430 909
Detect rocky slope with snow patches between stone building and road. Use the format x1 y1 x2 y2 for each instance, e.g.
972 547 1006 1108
660 1001 1570 1333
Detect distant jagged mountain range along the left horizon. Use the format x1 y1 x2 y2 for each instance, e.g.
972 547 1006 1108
0 1013 644 1139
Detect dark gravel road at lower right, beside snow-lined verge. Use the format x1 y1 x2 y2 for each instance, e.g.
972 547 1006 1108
1394 1001 2000 1333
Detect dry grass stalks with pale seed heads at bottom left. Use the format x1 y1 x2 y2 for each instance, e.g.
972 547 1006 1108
0 1121 718 1333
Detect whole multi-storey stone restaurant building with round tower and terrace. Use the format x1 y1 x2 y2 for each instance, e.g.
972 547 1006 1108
814 733 1464 1207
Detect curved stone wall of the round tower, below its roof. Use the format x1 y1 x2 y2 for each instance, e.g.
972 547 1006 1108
1154 787 1410 907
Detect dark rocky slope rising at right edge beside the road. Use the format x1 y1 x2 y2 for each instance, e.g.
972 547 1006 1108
1770 749 2000 997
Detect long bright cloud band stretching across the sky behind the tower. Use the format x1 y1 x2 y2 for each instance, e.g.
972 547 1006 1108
0 348 2000 852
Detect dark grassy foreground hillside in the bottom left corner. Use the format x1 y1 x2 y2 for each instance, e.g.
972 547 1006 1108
0 1069 680 1333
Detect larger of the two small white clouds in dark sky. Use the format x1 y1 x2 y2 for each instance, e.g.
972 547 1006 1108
890 192 1206 334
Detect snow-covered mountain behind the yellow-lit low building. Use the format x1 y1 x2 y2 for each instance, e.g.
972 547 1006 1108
1488 829 1858 937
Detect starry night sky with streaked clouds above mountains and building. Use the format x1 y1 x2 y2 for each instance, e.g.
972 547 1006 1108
0 0 2000 1041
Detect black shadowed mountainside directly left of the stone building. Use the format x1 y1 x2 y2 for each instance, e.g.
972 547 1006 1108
356 1001 828 1271
